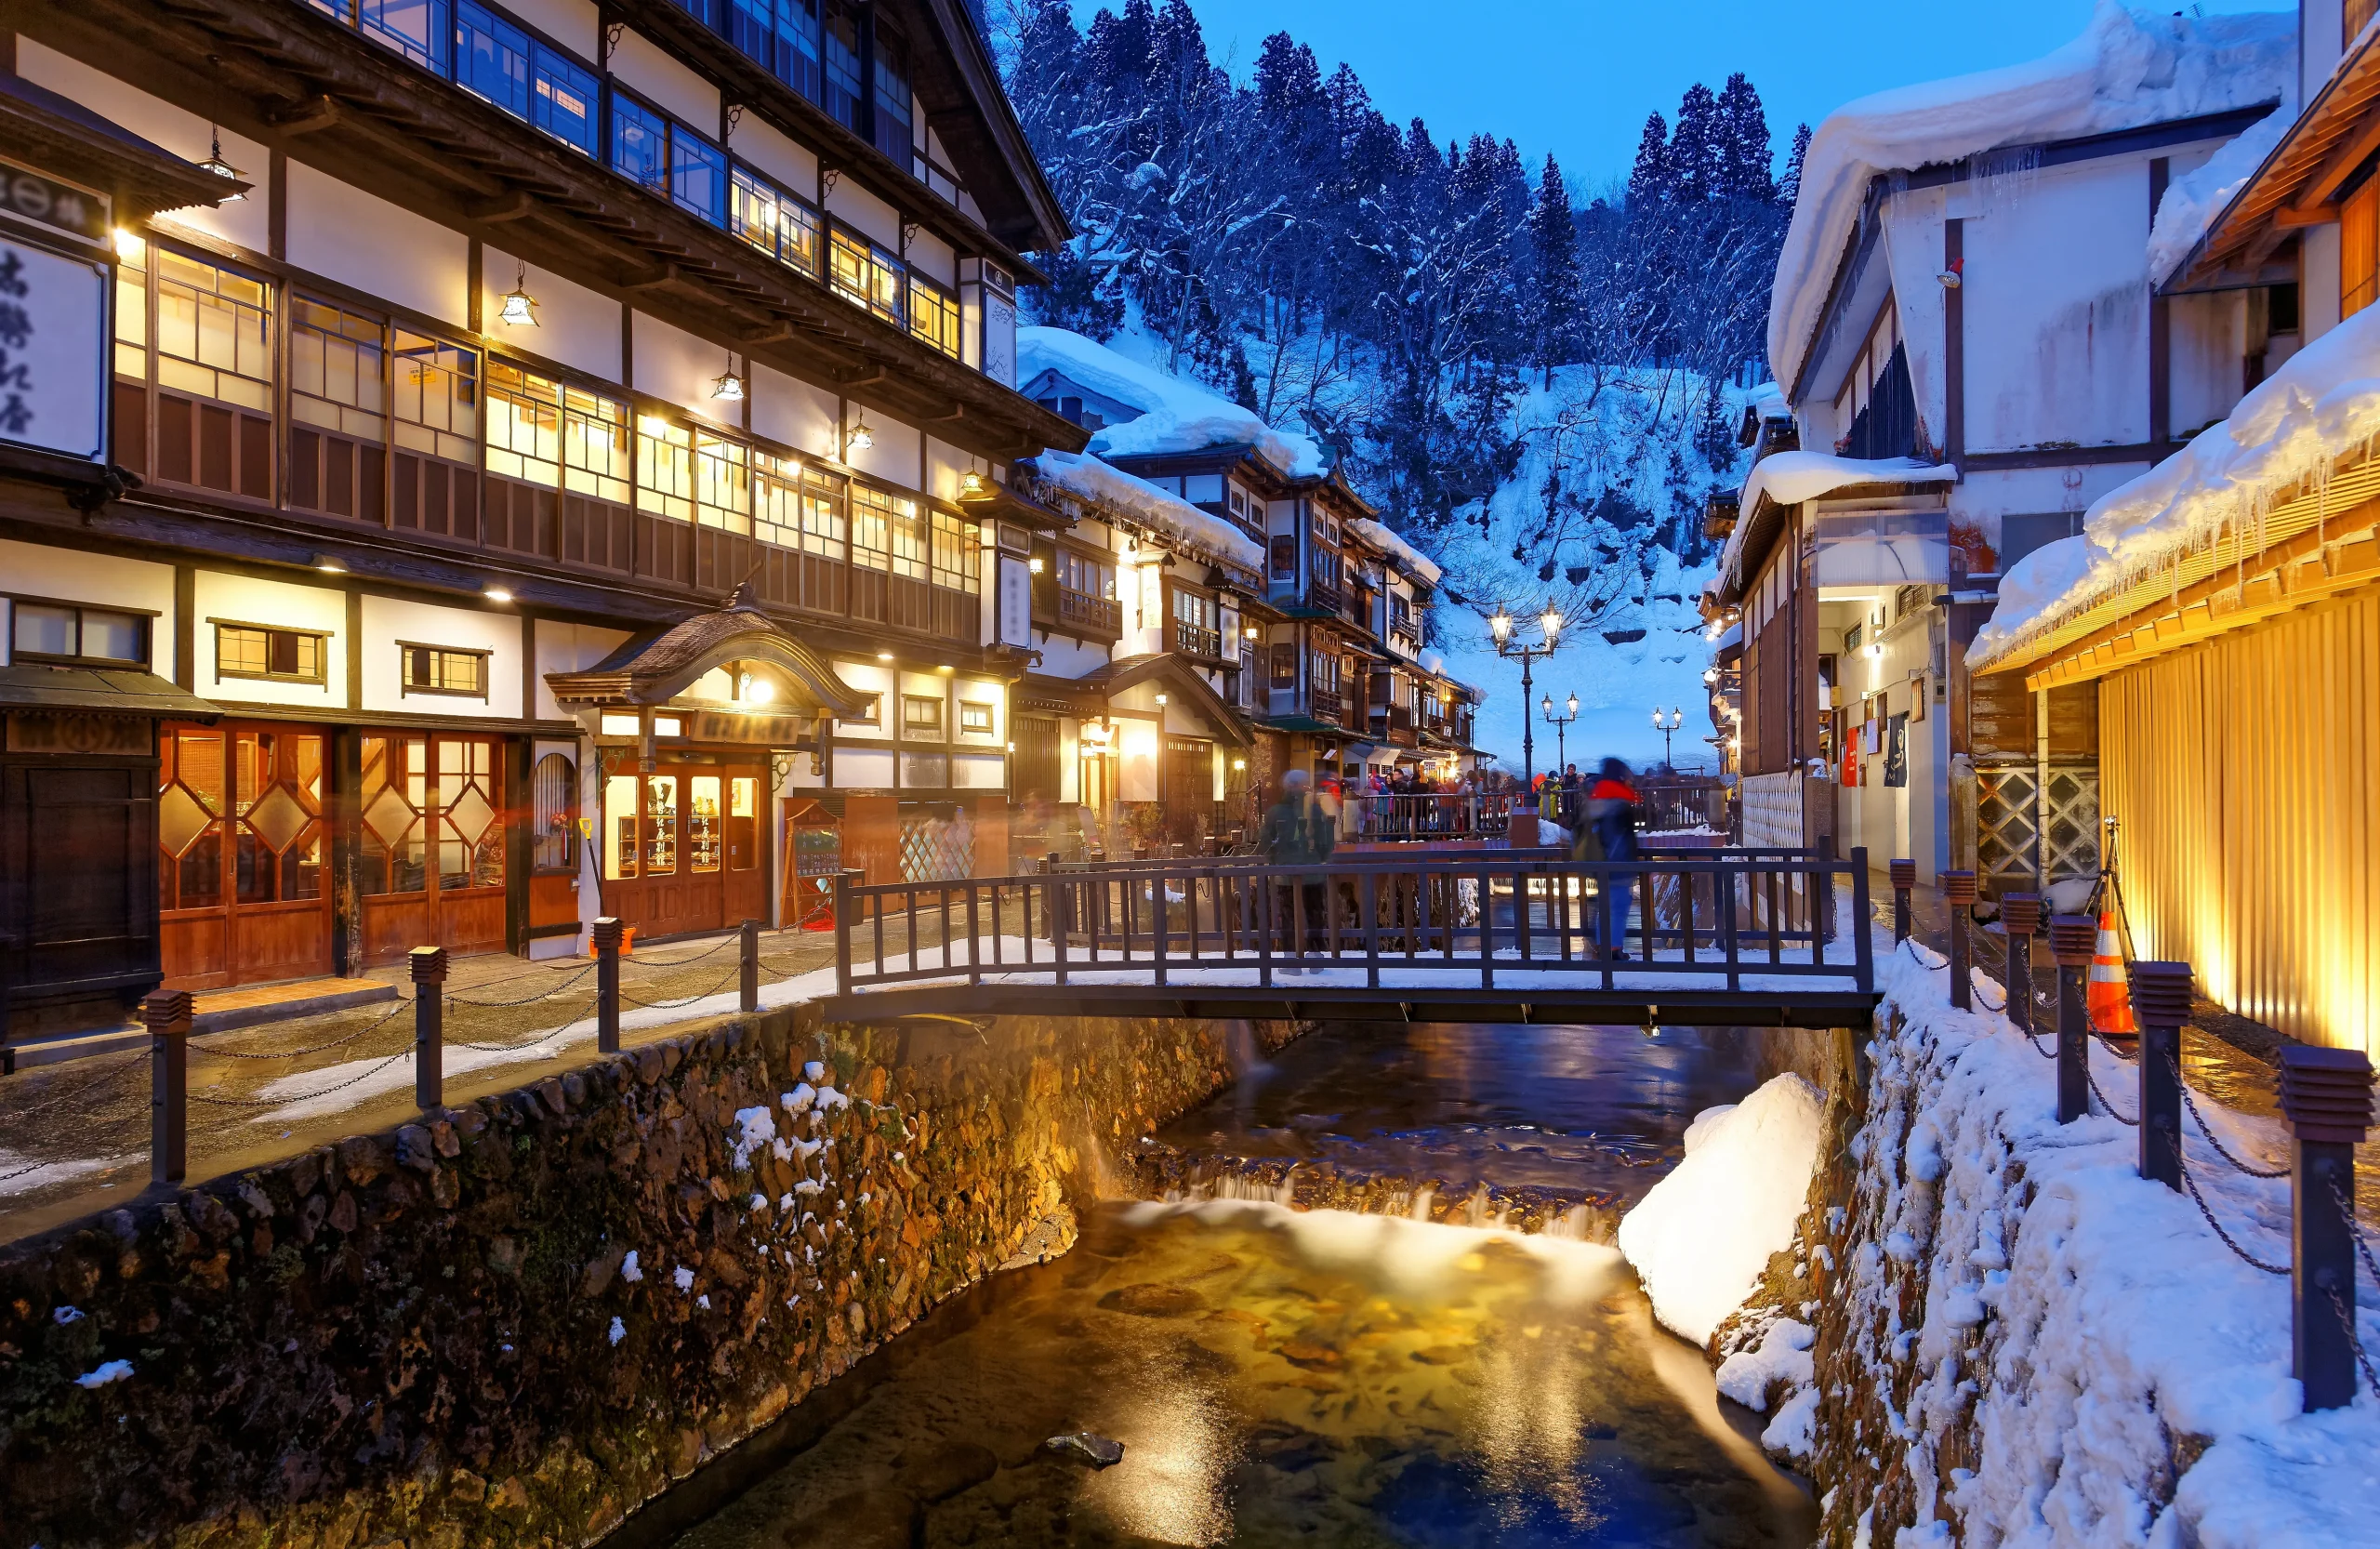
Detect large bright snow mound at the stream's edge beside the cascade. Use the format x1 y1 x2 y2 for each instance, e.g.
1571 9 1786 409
1619 1076 1823 1344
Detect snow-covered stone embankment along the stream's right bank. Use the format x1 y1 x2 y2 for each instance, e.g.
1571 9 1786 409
1764 928 2380 1549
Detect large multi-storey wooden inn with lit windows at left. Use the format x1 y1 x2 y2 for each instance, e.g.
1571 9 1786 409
0 0 1085 1026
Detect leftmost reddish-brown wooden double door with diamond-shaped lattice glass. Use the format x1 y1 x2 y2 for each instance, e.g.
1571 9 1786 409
157 721 331 990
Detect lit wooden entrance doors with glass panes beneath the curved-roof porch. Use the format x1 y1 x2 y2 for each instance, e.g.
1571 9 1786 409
598 759 769 940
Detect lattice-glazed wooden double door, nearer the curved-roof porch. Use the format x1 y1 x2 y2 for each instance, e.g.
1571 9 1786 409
357 731 505 963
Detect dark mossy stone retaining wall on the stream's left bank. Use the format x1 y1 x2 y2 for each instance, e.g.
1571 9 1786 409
0 1009 1292 1549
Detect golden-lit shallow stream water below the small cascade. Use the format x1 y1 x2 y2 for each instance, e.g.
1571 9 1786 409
683 1204 1816 1549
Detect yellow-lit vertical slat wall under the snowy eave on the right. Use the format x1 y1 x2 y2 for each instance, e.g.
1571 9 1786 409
2099 592 2380 1054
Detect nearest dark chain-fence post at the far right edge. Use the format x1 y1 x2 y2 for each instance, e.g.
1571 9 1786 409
2280 1044 2373 1411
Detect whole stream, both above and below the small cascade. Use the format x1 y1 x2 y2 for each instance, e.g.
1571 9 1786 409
676 1028 1816 1549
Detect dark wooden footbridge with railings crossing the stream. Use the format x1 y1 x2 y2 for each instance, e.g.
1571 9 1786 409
828 850 1878 1028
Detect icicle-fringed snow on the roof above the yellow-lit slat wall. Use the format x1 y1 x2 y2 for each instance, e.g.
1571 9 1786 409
1966 307 2380 667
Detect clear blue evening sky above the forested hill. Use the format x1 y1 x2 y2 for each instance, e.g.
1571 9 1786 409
1170 0 2294 186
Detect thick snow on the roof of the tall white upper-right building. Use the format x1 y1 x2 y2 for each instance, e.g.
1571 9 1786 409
1768 0 2296 394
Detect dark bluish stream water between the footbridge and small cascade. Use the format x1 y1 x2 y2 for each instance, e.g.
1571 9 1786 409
1157 1023 1766 1204
